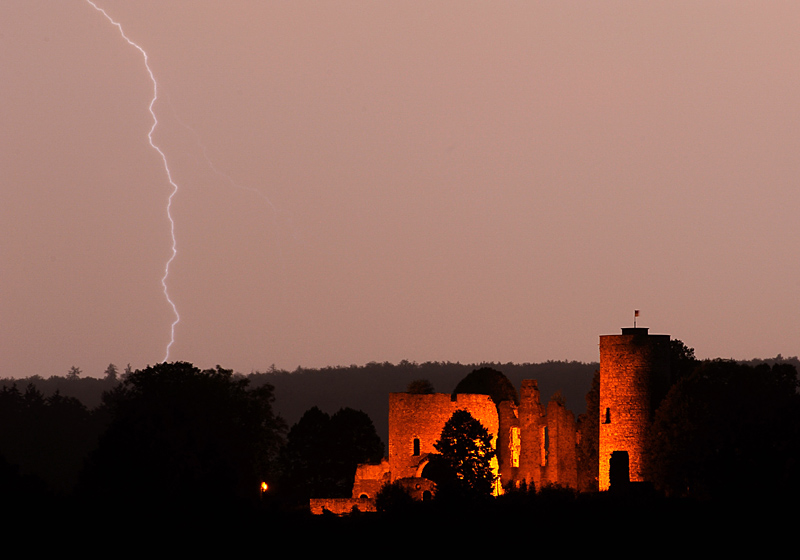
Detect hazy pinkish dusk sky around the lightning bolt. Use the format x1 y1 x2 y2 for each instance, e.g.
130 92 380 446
0 0 800 377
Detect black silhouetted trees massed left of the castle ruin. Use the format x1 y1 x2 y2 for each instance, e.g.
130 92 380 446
0 362 384 511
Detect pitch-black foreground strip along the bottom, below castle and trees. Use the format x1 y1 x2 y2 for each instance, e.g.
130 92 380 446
4 481 800 557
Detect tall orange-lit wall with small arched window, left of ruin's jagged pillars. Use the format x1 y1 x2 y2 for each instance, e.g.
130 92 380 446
389 393 499 481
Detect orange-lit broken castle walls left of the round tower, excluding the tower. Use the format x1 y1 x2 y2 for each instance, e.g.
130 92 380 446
346 372 578 499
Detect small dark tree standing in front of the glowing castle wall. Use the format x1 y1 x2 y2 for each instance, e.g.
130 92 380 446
425 410 497 499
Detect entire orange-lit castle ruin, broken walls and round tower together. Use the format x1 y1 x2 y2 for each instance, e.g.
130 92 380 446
311 327 670 513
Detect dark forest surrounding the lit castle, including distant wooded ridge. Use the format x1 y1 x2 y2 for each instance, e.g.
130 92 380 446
0 356 800 540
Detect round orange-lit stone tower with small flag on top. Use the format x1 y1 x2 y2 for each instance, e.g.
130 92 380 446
599 327 670 490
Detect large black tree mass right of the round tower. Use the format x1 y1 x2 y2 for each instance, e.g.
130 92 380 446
649 360 800 497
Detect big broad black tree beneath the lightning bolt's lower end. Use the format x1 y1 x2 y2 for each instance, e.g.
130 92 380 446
83 362 284 506
